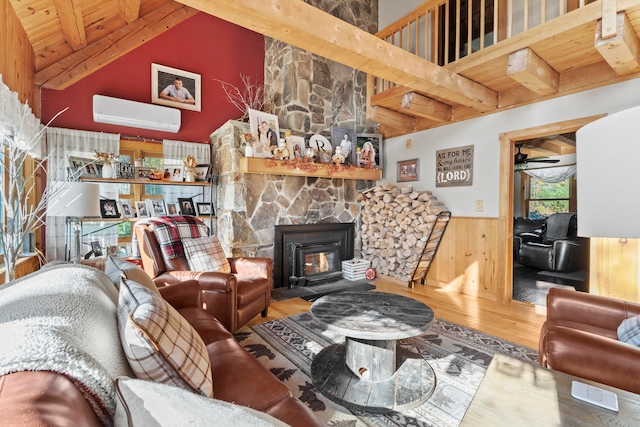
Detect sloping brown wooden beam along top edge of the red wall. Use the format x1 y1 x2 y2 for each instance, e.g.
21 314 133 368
35 2 198 89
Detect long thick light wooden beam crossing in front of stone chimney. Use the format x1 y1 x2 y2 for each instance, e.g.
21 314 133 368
176 0 498 112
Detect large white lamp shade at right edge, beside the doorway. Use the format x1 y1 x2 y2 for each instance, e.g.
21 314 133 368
576 107 640 238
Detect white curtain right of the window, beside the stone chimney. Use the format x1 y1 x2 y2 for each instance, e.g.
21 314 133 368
162 139 211 203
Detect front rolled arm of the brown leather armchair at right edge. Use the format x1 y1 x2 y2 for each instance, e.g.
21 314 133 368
539 325 640 393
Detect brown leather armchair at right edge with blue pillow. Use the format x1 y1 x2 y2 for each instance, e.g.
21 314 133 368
538 288 640 393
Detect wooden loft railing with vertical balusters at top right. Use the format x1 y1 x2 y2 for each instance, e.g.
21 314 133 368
374 0 595 93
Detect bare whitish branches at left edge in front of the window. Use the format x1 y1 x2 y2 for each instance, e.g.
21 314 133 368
0 104 66 283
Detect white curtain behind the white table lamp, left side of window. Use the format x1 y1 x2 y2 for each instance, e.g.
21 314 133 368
46 128 120 261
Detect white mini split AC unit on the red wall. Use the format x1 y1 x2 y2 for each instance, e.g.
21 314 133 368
93 95 180 133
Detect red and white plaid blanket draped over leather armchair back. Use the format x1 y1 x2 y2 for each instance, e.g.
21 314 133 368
149 215 209 259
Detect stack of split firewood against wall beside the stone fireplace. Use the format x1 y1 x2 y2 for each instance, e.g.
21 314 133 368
358 183 447 282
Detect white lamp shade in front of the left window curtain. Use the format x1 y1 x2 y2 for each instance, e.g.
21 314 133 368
47 181 101 218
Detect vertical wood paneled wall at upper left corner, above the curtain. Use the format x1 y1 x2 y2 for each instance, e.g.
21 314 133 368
0 0 40 117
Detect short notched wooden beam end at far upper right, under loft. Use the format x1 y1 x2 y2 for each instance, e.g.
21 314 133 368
595 12 640 76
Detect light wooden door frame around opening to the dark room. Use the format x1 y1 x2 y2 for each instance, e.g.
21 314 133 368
498 114 606 304
